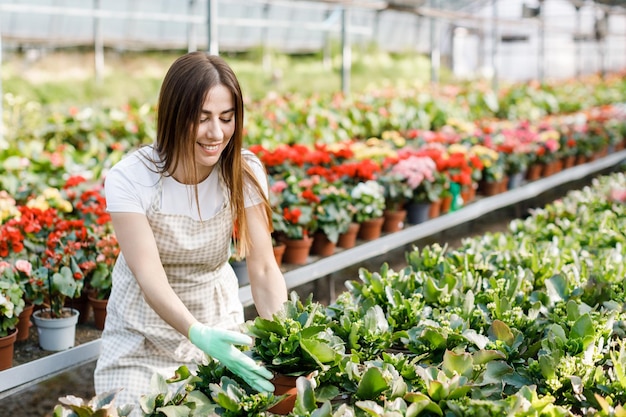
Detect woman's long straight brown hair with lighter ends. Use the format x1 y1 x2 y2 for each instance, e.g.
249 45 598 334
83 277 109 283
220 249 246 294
156 52 272 257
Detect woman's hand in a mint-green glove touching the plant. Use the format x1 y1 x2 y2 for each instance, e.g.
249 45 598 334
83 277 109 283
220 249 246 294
189 322 274 392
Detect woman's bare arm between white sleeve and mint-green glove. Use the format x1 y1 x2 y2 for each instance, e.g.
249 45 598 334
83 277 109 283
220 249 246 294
111 213 197 337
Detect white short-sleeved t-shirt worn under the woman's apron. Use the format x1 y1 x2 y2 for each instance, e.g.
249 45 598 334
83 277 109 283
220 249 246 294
104 146 268 220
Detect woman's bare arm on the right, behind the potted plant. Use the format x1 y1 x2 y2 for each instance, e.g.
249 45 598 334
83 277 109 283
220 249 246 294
246 205 287 319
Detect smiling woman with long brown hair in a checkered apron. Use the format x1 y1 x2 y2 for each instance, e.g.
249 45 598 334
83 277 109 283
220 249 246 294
95 52 287 405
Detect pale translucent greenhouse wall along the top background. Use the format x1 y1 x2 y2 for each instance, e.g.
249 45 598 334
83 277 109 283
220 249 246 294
0 0 626 80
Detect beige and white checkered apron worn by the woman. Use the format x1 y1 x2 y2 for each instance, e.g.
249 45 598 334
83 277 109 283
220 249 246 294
94 171 244 415
